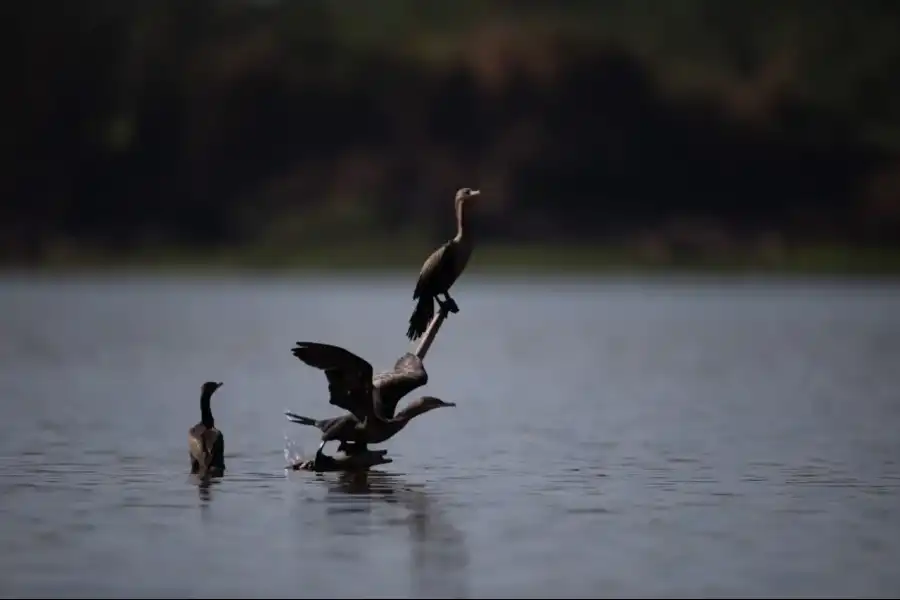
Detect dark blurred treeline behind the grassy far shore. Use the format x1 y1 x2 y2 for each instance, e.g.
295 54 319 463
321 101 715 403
0 0 900 261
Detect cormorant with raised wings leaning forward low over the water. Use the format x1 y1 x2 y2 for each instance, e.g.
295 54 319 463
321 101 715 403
285 342 456 468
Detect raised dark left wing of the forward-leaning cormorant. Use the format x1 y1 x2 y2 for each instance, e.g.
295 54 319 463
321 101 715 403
291 342 373 421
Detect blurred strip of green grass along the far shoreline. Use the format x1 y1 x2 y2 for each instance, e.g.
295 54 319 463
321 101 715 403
0 240 900 276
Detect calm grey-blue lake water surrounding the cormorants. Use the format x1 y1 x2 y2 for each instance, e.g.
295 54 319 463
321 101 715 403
0 276 900 598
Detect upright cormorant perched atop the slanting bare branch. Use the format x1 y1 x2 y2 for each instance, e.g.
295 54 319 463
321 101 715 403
406 188 481 341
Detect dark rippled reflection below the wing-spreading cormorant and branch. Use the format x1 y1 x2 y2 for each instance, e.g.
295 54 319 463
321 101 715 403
326 471 469 598
